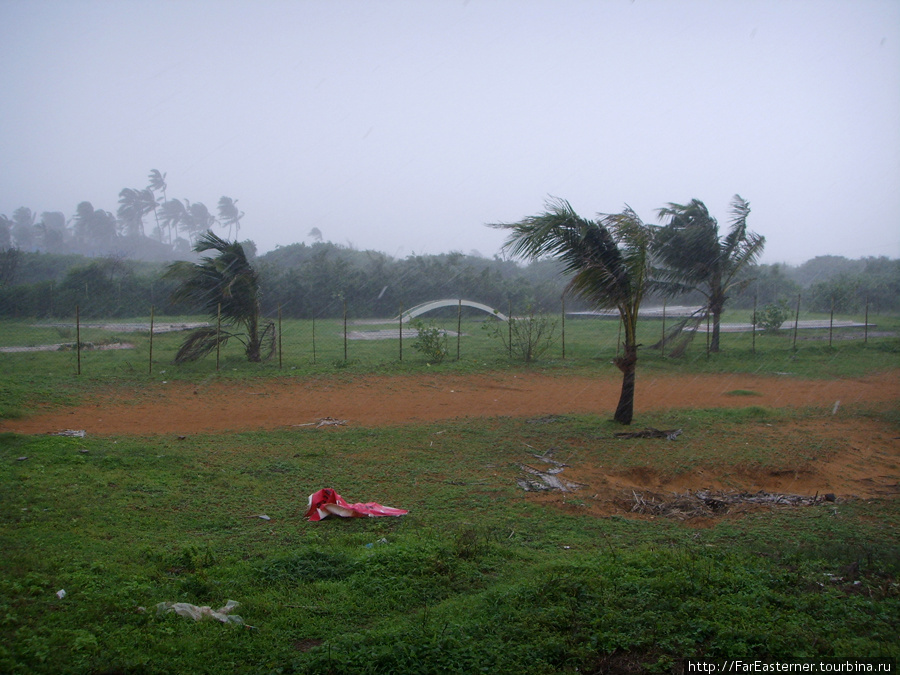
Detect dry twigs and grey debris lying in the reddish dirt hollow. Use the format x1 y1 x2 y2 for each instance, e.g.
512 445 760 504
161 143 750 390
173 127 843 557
627 490 836 520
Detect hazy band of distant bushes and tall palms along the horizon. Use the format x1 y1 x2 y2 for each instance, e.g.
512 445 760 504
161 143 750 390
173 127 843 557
0 169 900 318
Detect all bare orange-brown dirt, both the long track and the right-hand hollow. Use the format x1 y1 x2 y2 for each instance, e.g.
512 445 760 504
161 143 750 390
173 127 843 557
0 370 900 513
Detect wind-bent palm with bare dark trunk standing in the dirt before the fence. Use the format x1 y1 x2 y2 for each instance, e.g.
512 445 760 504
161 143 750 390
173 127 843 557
492 199 652 424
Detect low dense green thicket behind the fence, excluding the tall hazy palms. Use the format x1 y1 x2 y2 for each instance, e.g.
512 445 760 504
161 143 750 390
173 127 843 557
0 242 900 318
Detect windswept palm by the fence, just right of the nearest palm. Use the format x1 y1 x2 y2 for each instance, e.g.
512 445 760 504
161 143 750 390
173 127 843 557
654 195 766 352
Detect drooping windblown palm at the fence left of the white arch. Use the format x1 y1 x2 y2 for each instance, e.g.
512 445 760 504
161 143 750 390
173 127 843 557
166 232 275 363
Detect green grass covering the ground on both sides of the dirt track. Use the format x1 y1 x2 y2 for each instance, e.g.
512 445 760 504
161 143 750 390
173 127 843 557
0 317 900 674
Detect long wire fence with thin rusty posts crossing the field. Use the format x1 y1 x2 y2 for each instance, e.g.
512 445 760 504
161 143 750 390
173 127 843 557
0 296 898 377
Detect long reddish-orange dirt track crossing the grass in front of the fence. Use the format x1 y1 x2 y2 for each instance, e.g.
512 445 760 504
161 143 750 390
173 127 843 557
0 370 900 436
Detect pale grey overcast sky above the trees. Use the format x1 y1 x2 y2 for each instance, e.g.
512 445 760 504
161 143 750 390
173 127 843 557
0 0 900 263
